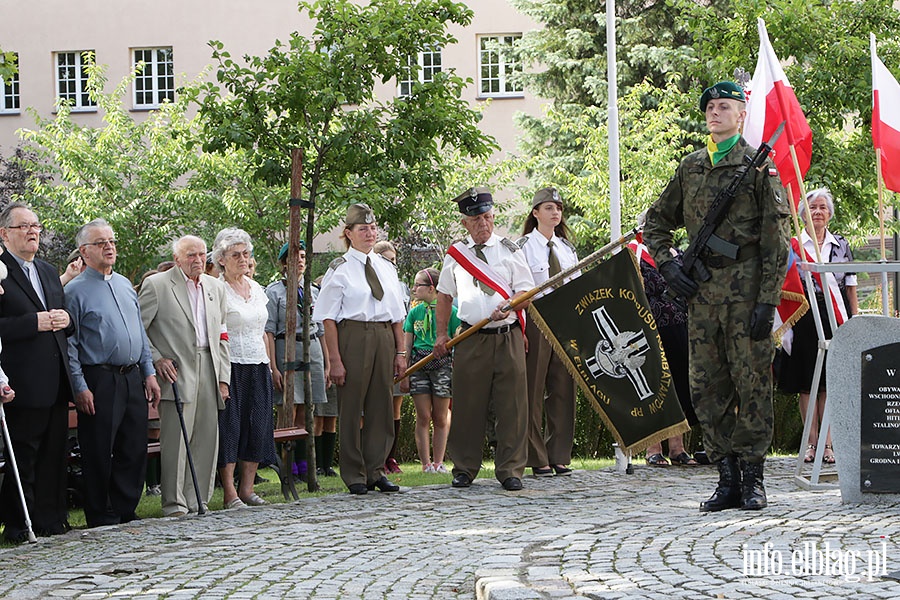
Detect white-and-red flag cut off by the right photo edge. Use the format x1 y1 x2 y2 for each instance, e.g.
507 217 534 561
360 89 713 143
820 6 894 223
869 34 900 192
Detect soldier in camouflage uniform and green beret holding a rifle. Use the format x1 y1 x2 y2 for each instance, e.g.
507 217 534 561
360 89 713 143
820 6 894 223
644 81 790 512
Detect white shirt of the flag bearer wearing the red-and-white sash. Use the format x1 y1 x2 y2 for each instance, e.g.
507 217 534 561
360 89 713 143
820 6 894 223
437 233 534 328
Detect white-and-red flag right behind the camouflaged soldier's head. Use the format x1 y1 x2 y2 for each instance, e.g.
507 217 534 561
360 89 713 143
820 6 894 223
744 19 812 206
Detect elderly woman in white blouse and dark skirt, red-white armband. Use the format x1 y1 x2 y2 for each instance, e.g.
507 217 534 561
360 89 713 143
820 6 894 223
212 227 275 508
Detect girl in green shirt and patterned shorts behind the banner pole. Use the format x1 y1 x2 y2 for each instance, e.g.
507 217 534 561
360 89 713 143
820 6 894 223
403 268 460 473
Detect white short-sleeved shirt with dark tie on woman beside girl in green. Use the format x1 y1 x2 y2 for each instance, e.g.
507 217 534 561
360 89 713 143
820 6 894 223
313 248 406 323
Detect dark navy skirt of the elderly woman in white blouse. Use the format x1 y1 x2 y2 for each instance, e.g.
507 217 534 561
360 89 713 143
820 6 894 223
218 363 276 468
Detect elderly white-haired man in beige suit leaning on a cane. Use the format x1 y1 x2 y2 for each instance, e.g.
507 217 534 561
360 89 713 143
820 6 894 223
139 235 231 516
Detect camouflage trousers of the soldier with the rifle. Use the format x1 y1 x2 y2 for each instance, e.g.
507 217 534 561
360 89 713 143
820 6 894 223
688 302 775 462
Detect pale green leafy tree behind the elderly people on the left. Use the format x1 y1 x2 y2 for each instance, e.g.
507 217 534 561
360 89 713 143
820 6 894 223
19 61 283 280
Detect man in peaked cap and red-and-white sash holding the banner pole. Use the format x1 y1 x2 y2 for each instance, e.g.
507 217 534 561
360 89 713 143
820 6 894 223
434 187 534 491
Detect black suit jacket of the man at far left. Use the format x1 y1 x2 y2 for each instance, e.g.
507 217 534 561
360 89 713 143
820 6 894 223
0 251 74 408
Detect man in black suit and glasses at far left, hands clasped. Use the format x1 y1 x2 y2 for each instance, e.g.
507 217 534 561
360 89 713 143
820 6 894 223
0 202 73 542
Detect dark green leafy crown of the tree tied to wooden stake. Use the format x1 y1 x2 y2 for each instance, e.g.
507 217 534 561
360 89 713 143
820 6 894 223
197 0 496 231
